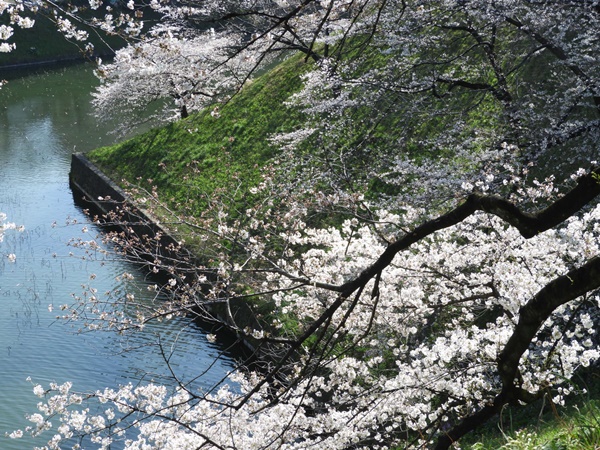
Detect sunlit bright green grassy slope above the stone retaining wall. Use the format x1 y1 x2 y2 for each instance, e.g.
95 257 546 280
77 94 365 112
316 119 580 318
88 57 308 213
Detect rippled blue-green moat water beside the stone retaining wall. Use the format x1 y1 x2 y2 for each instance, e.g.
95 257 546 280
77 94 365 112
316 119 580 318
0 66 230 450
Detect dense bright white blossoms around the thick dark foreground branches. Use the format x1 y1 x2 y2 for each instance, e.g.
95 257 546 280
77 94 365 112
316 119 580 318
13 191 600 449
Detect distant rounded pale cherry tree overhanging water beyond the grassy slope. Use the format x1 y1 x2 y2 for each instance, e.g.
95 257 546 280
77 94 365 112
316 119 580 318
94 27 244 134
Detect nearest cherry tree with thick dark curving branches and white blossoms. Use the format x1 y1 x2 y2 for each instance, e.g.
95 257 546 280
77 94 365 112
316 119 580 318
12 169 600 448
